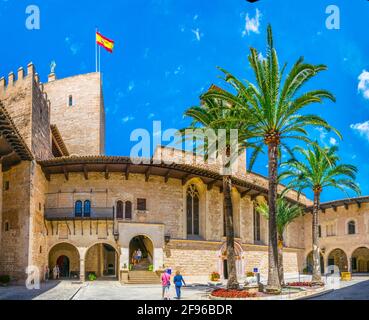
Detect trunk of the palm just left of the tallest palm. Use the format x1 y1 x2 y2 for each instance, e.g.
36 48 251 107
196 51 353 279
223 175 239 289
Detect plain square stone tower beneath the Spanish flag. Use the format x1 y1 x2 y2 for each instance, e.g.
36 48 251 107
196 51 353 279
45 73 105 155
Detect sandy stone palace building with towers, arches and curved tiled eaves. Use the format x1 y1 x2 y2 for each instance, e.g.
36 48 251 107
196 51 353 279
0 63 369 283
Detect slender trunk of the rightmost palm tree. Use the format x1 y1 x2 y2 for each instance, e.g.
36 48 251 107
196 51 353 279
312 191 322 282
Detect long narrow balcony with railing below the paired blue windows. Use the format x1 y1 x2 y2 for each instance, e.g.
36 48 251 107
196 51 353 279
45 207 114 221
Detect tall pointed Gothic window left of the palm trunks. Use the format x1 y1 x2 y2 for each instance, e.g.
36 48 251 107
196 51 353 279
186 184 200 235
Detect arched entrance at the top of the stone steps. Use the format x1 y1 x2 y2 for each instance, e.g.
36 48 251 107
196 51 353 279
129 235 154 271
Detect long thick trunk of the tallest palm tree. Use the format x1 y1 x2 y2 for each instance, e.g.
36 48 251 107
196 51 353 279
266 142 281 294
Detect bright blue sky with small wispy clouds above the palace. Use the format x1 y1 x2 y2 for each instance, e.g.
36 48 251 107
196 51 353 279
0 0 369 200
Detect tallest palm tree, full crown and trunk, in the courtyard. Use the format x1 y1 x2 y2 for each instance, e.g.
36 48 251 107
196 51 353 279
201 25 340 293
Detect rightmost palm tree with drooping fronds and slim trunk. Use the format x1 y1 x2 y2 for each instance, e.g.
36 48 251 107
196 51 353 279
280 143 361 282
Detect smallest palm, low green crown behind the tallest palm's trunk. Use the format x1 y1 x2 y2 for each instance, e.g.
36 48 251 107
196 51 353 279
256 197 302 286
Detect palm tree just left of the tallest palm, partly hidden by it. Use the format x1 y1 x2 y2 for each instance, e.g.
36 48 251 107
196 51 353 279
181 91 247 289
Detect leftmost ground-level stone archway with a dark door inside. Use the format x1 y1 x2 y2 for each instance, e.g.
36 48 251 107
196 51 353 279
49 243 80 279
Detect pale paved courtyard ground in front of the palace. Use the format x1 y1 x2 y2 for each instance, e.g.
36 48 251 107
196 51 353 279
0 277 369 300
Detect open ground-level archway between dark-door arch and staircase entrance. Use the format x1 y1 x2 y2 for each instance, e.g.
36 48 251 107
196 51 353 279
85 243 119 280
